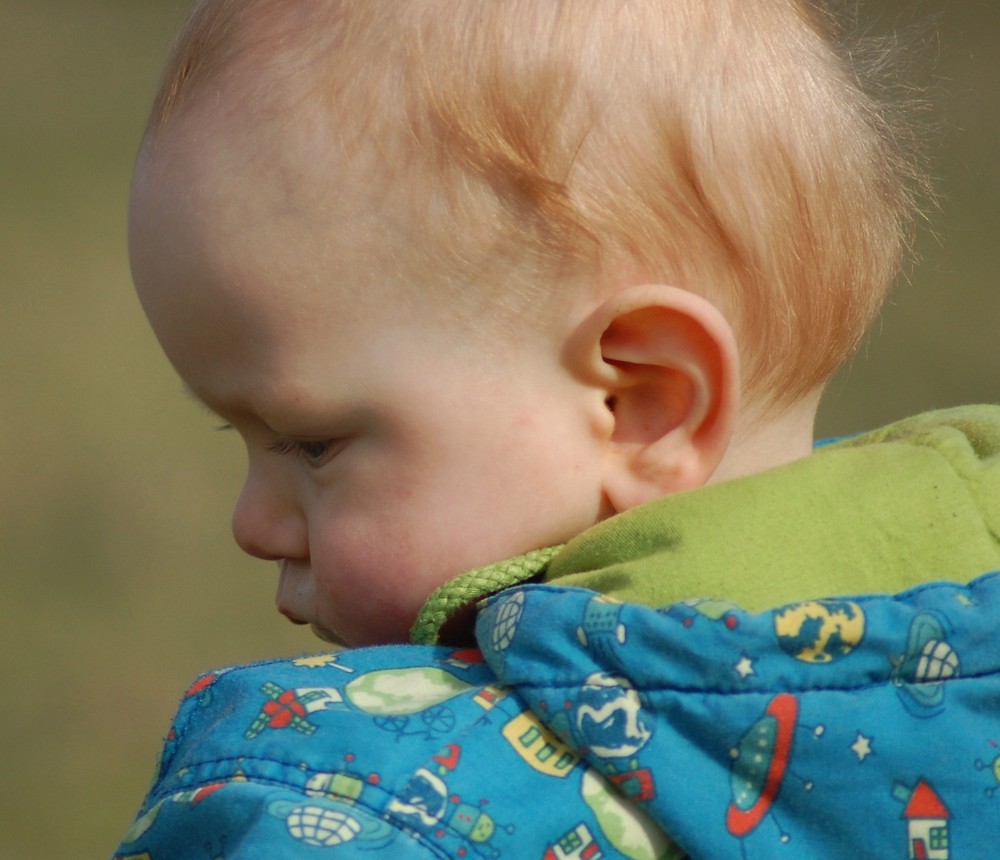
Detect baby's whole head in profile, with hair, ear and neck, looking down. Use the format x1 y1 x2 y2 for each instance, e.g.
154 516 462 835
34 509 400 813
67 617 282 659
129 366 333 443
130 0 911 644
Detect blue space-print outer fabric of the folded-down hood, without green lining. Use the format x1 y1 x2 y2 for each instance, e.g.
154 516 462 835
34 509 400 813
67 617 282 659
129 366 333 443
477 574 1000 860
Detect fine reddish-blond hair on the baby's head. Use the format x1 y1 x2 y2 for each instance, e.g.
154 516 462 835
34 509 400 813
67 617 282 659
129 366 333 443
143 0 918 404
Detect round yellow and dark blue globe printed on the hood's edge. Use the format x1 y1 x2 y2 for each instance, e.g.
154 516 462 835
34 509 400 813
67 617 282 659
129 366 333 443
774 600 865 663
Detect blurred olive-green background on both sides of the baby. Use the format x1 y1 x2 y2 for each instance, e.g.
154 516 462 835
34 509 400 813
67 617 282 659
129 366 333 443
0 0 1000 860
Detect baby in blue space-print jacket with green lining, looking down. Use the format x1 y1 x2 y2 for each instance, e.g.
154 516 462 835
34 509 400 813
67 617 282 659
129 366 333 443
121 0 1000 860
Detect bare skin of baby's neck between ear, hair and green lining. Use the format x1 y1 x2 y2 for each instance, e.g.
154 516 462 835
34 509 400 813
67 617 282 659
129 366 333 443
708 390 822 484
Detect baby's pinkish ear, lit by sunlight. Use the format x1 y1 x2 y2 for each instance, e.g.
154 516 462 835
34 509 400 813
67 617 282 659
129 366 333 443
568 284 739 512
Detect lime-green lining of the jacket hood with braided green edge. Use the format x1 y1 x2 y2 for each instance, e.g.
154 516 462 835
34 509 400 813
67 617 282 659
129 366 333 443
411 406 1000 643
